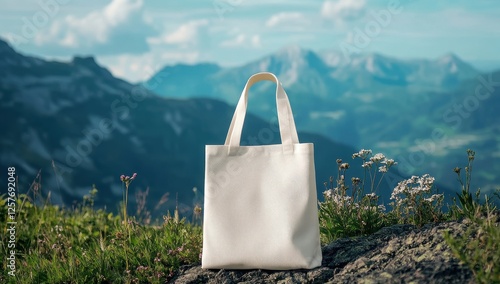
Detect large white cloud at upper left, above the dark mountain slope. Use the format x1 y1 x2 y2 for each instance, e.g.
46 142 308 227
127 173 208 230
35 0 154 54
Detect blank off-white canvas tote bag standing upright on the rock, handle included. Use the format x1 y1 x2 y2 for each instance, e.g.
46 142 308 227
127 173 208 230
202 73 322 270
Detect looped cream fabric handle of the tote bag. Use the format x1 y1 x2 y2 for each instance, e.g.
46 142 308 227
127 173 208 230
224 72 299 153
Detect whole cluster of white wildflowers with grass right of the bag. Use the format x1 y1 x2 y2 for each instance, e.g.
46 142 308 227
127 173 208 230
320 149 450 243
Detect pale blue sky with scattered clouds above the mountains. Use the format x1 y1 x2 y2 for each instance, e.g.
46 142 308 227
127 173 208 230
0 0 500 82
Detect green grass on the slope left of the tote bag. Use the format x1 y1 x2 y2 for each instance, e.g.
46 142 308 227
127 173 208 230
0 180 202 283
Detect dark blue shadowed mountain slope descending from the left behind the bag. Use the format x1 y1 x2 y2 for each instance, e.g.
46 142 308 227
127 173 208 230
0 41 376 216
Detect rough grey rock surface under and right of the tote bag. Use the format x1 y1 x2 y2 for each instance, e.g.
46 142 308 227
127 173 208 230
171 221 475 284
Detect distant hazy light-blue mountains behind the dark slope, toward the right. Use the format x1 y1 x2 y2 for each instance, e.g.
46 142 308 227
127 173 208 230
145 46 500 195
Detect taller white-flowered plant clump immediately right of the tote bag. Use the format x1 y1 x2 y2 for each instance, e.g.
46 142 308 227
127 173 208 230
319 149 397 243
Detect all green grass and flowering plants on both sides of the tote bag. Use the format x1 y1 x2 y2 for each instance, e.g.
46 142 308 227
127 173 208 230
0 150 500 283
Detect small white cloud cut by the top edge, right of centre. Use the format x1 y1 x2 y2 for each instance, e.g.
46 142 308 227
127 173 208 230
321 0 366 22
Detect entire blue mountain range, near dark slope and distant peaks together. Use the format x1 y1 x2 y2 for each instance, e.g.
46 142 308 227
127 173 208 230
0 37 500 219
